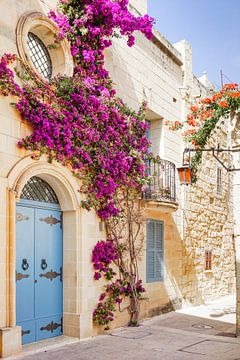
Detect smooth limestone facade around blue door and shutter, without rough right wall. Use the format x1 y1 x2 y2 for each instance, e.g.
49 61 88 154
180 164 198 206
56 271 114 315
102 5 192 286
0 0 185 337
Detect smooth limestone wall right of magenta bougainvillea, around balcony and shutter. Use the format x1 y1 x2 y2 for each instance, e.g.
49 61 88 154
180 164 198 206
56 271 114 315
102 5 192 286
106 22 186 320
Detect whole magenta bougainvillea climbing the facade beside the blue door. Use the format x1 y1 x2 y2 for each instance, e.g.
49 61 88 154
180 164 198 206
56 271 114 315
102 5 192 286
0 0 153 324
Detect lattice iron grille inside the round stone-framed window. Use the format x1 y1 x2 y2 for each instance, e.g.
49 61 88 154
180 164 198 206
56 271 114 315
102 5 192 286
27 32 52 81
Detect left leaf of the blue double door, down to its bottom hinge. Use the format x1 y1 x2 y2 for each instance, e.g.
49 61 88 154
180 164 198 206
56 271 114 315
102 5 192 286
16 206 34 322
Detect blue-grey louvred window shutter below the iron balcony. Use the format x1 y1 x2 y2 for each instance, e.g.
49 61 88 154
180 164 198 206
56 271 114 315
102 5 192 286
146 220 164 282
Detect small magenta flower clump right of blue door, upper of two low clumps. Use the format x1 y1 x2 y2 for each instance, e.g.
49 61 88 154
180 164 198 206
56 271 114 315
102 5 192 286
92 240 119 280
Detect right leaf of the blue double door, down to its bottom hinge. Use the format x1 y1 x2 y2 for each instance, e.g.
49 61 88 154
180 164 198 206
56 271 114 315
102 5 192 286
35 209 62 318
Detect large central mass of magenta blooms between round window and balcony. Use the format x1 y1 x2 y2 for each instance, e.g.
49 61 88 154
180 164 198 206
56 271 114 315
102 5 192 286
16 79 149 219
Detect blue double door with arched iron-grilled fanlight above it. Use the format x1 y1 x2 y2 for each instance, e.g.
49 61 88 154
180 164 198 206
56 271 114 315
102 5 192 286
16 176 63 344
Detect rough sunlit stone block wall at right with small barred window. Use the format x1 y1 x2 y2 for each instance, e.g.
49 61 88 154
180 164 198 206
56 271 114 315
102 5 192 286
182 129 235 305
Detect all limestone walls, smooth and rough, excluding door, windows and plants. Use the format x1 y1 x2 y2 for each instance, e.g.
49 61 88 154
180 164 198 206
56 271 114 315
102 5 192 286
0 0 234 348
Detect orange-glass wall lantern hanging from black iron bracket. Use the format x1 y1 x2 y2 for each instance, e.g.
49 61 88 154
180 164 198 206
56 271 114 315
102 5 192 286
177 146 240 185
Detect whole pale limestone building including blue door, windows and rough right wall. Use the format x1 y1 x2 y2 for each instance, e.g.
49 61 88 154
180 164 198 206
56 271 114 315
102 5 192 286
0 0 234 357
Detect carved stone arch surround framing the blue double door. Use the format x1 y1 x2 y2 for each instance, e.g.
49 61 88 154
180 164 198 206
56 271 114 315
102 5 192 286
7 156 82 337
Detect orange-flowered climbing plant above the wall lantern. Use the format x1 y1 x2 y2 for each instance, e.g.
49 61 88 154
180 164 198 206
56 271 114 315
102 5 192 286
165 84 240 174
